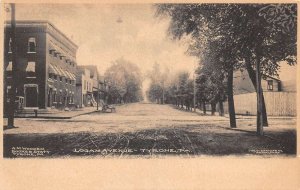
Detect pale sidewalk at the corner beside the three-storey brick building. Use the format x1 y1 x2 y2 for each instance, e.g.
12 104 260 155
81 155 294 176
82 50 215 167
12 107 101 119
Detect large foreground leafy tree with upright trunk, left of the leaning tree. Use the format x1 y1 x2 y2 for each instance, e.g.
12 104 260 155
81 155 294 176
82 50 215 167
157 4 238 128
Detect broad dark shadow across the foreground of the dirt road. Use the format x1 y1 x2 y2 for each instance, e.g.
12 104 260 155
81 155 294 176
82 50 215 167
4 125 296 158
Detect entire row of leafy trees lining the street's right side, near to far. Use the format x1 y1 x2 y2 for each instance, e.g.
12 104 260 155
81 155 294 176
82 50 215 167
152 4 297 135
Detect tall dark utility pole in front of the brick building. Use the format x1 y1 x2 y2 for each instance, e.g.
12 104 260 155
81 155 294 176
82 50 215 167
7 3 17 128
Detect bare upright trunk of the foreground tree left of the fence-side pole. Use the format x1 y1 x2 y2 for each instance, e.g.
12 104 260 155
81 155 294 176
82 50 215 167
227 66 236 128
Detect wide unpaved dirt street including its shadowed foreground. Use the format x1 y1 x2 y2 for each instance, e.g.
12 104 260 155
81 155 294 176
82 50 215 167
4 103 296 157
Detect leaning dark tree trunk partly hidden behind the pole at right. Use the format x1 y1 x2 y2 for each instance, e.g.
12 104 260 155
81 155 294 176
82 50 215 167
245 57 269 127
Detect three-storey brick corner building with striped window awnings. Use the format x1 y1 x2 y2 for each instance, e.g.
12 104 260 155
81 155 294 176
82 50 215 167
3 21 78 109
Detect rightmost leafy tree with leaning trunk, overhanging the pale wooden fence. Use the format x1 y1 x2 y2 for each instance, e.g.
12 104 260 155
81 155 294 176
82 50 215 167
237 4 296 130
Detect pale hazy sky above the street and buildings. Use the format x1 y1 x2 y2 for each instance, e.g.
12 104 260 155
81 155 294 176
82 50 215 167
5 4 196 74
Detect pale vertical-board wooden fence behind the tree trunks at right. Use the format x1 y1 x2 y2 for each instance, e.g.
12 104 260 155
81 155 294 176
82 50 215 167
224 92 297 116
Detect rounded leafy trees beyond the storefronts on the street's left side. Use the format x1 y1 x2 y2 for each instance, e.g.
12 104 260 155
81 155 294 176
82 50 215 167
104 58 143 104
